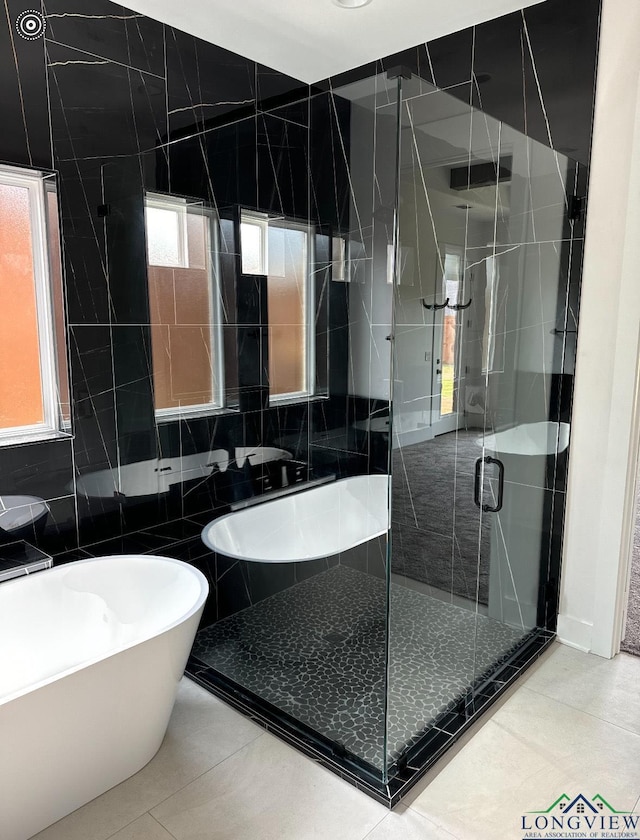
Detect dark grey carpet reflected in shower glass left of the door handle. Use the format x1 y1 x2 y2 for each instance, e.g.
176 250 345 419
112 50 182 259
391 430 491 605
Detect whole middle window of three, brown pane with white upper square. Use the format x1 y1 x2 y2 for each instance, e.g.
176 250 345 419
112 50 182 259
145 193 224 420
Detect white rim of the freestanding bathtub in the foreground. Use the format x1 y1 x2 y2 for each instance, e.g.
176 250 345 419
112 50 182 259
0 554 209 709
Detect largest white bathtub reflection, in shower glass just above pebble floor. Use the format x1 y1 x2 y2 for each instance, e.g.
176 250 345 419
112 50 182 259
202 475 389 563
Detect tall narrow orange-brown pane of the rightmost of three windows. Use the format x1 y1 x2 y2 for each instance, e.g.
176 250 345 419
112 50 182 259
267 227 307 396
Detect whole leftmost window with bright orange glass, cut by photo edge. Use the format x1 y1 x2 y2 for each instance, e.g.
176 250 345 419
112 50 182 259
0 161 70 444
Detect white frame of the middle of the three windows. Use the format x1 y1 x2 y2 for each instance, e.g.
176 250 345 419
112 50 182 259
144 190 226 423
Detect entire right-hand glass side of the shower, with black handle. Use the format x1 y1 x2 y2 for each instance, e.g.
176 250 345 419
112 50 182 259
387 77 573 773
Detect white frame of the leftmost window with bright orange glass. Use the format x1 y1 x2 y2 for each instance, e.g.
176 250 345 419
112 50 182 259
0 165 71 446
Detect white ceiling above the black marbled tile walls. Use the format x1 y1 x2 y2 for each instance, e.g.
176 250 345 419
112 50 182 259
119 0 542 83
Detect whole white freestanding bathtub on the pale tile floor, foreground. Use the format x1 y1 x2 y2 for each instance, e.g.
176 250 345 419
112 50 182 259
0 555 208 840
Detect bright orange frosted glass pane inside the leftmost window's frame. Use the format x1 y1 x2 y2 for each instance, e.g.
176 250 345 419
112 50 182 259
0 184 44 429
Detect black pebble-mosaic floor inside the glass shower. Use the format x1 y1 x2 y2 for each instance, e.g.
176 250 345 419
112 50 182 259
193 566 524 768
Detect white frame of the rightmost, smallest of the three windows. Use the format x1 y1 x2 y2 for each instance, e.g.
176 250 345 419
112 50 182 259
239 208 316 406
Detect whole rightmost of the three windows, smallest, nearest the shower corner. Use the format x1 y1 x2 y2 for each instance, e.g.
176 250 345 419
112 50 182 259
240 211 315 402
